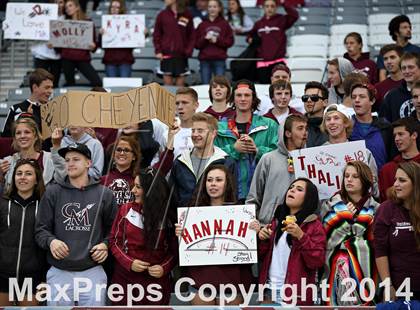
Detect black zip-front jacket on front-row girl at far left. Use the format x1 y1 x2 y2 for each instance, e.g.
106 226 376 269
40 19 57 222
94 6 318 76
0 198 47 281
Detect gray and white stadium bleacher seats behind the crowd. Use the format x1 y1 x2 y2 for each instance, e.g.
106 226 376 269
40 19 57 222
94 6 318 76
0 0 420 126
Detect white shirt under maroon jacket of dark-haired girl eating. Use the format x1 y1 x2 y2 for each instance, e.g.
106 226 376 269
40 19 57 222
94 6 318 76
268 232 290 290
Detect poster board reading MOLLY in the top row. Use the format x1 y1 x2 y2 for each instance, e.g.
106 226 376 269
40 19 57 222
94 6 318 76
50 20 93 50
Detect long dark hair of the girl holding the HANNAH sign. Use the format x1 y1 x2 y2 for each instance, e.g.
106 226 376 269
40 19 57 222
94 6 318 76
190 164 236 207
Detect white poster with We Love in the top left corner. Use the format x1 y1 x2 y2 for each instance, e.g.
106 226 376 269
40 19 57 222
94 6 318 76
3 2 58 41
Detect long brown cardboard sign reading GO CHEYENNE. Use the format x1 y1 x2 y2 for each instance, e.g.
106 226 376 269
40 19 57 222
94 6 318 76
41 83 175 138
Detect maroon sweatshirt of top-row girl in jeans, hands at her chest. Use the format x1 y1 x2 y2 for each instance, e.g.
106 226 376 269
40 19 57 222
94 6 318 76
195 16 234 60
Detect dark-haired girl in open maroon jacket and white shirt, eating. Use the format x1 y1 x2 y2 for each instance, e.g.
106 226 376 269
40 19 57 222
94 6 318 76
258 178 326 306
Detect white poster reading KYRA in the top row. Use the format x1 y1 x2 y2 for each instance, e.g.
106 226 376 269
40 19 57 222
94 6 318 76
102 14 145 48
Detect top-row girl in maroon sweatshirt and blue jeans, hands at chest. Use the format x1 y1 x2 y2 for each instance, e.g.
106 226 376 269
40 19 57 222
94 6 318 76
195 0 234 84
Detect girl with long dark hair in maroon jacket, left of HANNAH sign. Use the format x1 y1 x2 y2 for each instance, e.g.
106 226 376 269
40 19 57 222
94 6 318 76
109 168 176 306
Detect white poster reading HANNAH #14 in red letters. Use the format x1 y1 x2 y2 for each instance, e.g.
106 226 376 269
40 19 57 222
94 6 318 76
178 205 257 266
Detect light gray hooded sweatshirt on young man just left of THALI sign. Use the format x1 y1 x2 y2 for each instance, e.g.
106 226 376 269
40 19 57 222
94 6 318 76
246 121 295 224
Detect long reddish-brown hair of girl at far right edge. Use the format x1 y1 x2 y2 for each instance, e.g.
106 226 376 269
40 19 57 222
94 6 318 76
390 161 420 251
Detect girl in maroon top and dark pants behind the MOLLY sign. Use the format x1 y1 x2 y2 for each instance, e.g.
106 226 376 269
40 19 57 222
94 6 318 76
61 0 102 86
